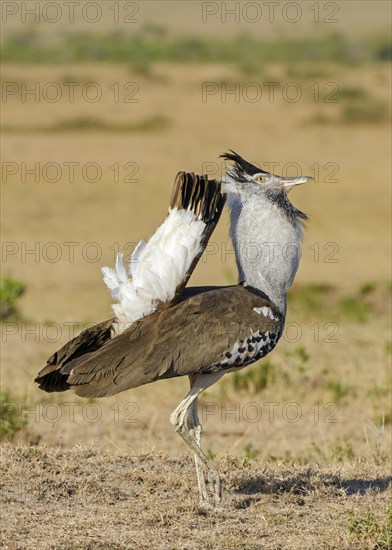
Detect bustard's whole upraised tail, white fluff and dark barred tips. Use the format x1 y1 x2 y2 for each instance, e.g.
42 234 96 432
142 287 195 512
102 172 225 335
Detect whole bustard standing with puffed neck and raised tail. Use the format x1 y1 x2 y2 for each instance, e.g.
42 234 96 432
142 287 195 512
36 154 310 504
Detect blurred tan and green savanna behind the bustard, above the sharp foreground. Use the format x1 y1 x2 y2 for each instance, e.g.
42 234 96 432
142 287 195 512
1 0 391 462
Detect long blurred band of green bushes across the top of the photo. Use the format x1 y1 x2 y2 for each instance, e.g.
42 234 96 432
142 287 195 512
2 25 391 65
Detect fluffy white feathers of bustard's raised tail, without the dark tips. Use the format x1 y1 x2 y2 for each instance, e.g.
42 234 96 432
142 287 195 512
102 209 206 334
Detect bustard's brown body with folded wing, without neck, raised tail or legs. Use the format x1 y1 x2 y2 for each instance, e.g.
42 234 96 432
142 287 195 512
36 285 283 397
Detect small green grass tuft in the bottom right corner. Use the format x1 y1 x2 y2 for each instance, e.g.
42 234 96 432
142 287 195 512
348 505 392 550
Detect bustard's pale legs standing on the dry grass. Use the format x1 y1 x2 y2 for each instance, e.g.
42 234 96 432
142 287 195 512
170 373 223 506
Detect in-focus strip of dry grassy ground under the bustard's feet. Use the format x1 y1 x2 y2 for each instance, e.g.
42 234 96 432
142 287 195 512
2 445 392 550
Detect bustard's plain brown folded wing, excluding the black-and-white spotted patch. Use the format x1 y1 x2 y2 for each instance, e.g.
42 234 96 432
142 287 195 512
62 286 282 397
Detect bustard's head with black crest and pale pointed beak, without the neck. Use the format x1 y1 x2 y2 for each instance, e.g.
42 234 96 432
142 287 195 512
221 151 313 220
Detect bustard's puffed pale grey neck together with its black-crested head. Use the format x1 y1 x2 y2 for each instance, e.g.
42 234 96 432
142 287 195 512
223 152 311 316
